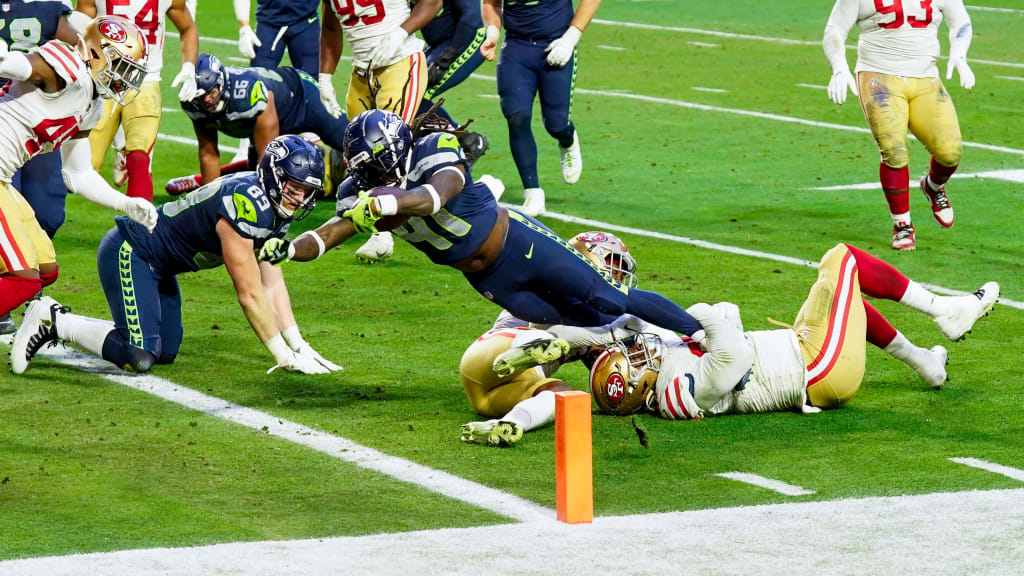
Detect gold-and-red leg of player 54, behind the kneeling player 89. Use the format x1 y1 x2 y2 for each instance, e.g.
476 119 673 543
121 82 162 202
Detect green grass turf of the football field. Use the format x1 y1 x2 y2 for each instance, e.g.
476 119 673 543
0 0 1024 560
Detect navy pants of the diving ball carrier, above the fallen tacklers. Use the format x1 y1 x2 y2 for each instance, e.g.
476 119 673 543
466 210 700 335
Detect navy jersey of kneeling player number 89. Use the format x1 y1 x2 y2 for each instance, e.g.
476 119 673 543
115 172 289 277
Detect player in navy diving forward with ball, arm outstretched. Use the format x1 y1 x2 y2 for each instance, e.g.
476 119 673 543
260 110 700 362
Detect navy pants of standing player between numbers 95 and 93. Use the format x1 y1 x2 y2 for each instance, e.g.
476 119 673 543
498 38 578 189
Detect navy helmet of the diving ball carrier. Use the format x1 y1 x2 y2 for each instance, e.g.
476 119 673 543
344 110 413 190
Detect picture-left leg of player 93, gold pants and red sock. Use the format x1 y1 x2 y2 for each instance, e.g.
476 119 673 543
857 72 914 250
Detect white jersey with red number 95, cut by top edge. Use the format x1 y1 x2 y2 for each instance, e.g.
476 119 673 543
331 0 425 69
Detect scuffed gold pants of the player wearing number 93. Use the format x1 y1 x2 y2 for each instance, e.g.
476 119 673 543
857 72 962 168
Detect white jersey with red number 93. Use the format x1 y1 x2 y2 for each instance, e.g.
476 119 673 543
827 0 971 78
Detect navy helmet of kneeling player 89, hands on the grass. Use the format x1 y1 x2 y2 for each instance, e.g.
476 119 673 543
256 134 324 220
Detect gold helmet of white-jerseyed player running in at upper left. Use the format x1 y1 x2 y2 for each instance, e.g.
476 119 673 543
79 15 150 106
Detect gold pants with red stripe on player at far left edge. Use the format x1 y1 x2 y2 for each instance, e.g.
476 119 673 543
0 181 57 275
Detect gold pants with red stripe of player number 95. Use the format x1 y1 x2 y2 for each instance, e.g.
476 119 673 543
345 52 427 124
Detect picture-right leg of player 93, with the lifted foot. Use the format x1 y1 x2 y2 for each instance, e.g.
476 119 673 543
910 78 963 228
